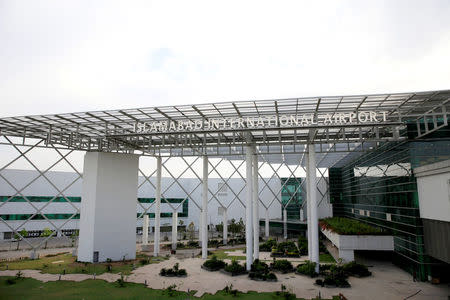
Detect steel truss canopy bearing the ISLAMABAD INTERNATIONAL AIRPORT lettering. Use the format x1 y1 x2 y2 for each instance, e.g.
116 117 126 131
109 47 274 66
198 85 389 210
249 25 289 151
0 90 450 166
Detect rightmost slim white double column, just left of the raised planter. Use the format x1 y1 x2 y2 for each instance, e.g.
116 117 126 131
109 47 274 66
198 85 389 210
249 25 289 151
307 144 319 272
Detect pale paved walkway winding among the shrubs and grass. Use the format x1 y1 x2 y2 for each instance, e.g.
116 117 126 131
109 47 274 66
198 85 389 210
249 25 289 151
0 257 450 300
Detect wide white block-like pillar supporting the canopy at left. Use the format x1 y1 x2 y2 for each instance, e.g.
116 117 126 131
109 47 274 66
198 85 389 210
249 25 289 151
78 152 139 262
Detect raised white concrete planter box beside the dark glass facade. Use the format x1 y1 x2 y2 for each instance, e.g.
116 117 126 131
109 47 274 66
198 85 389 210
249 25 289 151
321 229 394 262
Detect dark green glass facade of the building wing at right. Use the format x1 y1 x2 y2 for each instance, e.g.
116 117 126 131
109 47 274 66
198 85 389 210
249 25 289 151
329 126 450 280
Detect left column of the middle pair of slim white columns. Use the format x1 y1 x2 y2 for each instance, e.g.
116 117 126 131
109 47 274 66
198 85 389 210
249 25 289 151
245 146 253 271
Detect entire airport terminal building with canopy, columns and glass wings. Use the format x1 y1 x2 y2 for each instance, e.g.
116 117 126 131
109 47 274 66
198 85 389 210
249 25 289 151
0 90 450 280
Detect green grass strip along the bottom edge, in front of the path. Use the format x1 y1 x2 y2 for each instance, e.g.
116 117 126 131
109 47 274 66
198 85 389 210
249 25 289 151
0 277 339 300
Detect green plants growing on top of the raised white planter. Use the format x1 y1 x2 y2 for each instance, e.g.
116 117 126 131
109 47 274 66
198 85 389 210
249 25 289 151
319 217 388 235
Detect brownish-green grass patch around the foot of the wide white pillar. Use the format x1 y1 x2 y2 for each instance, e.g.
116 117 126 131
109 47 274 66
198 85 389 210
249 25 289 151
0 253 166 275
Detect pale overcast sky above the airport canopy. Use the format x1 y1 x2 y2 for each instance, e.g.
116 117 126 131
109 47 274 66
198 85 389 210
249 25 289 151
0 0 450 116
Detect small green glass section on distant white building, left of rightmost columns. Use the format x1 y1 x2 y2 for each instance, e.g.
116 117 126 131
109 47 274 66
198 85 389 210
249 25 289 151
281 178 302 220
